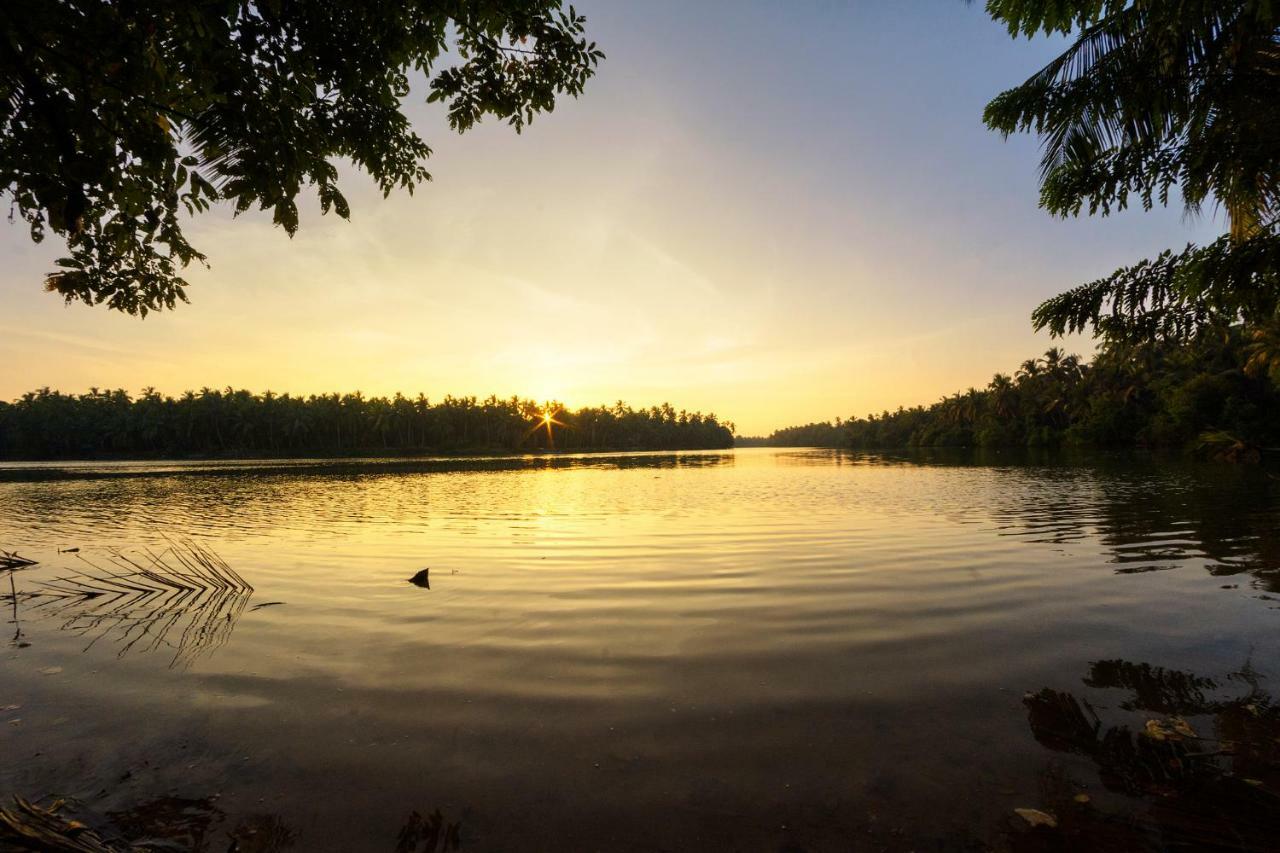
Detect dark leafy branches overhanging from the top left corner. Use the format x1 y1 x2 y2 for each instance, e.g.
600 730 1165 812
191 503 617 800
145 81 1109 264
0 0 603 315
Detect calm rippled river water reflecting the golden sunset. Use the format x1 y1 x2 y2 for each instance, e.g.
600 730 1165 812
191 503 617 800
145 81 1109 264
0 450 1280 853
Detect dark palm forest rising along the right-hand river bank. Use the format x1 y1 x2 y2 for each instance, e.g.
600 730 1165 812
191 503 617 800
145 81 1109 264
739 325 1280 457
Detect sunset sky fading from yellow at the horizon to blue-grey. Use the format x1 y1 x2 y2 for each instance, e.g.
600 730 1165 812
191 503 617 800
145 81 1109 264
0 0 1224 434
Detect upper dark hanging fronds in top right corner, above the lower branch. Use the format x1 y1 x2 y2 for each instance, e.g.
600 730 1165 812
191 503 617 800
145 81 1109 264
986 0 1280 240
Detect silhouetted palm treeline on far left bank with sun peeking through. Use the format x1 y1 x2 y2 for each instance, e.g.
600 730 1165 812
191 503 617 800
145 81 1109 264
0 388 733 459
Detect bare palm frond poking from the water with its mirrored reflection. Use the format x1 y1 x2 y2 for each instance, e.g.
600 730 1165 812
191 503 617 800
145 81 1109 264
0 542 253 667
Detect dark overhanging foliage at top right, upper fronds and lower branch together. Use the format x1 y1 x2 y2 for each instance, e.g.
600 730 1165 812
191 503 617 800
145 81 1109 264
984 0 1280 342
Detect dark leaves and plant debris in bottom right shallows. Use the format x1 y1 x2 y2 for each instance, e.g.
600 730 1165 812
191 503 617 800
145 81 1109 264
1015 661 1280 850
